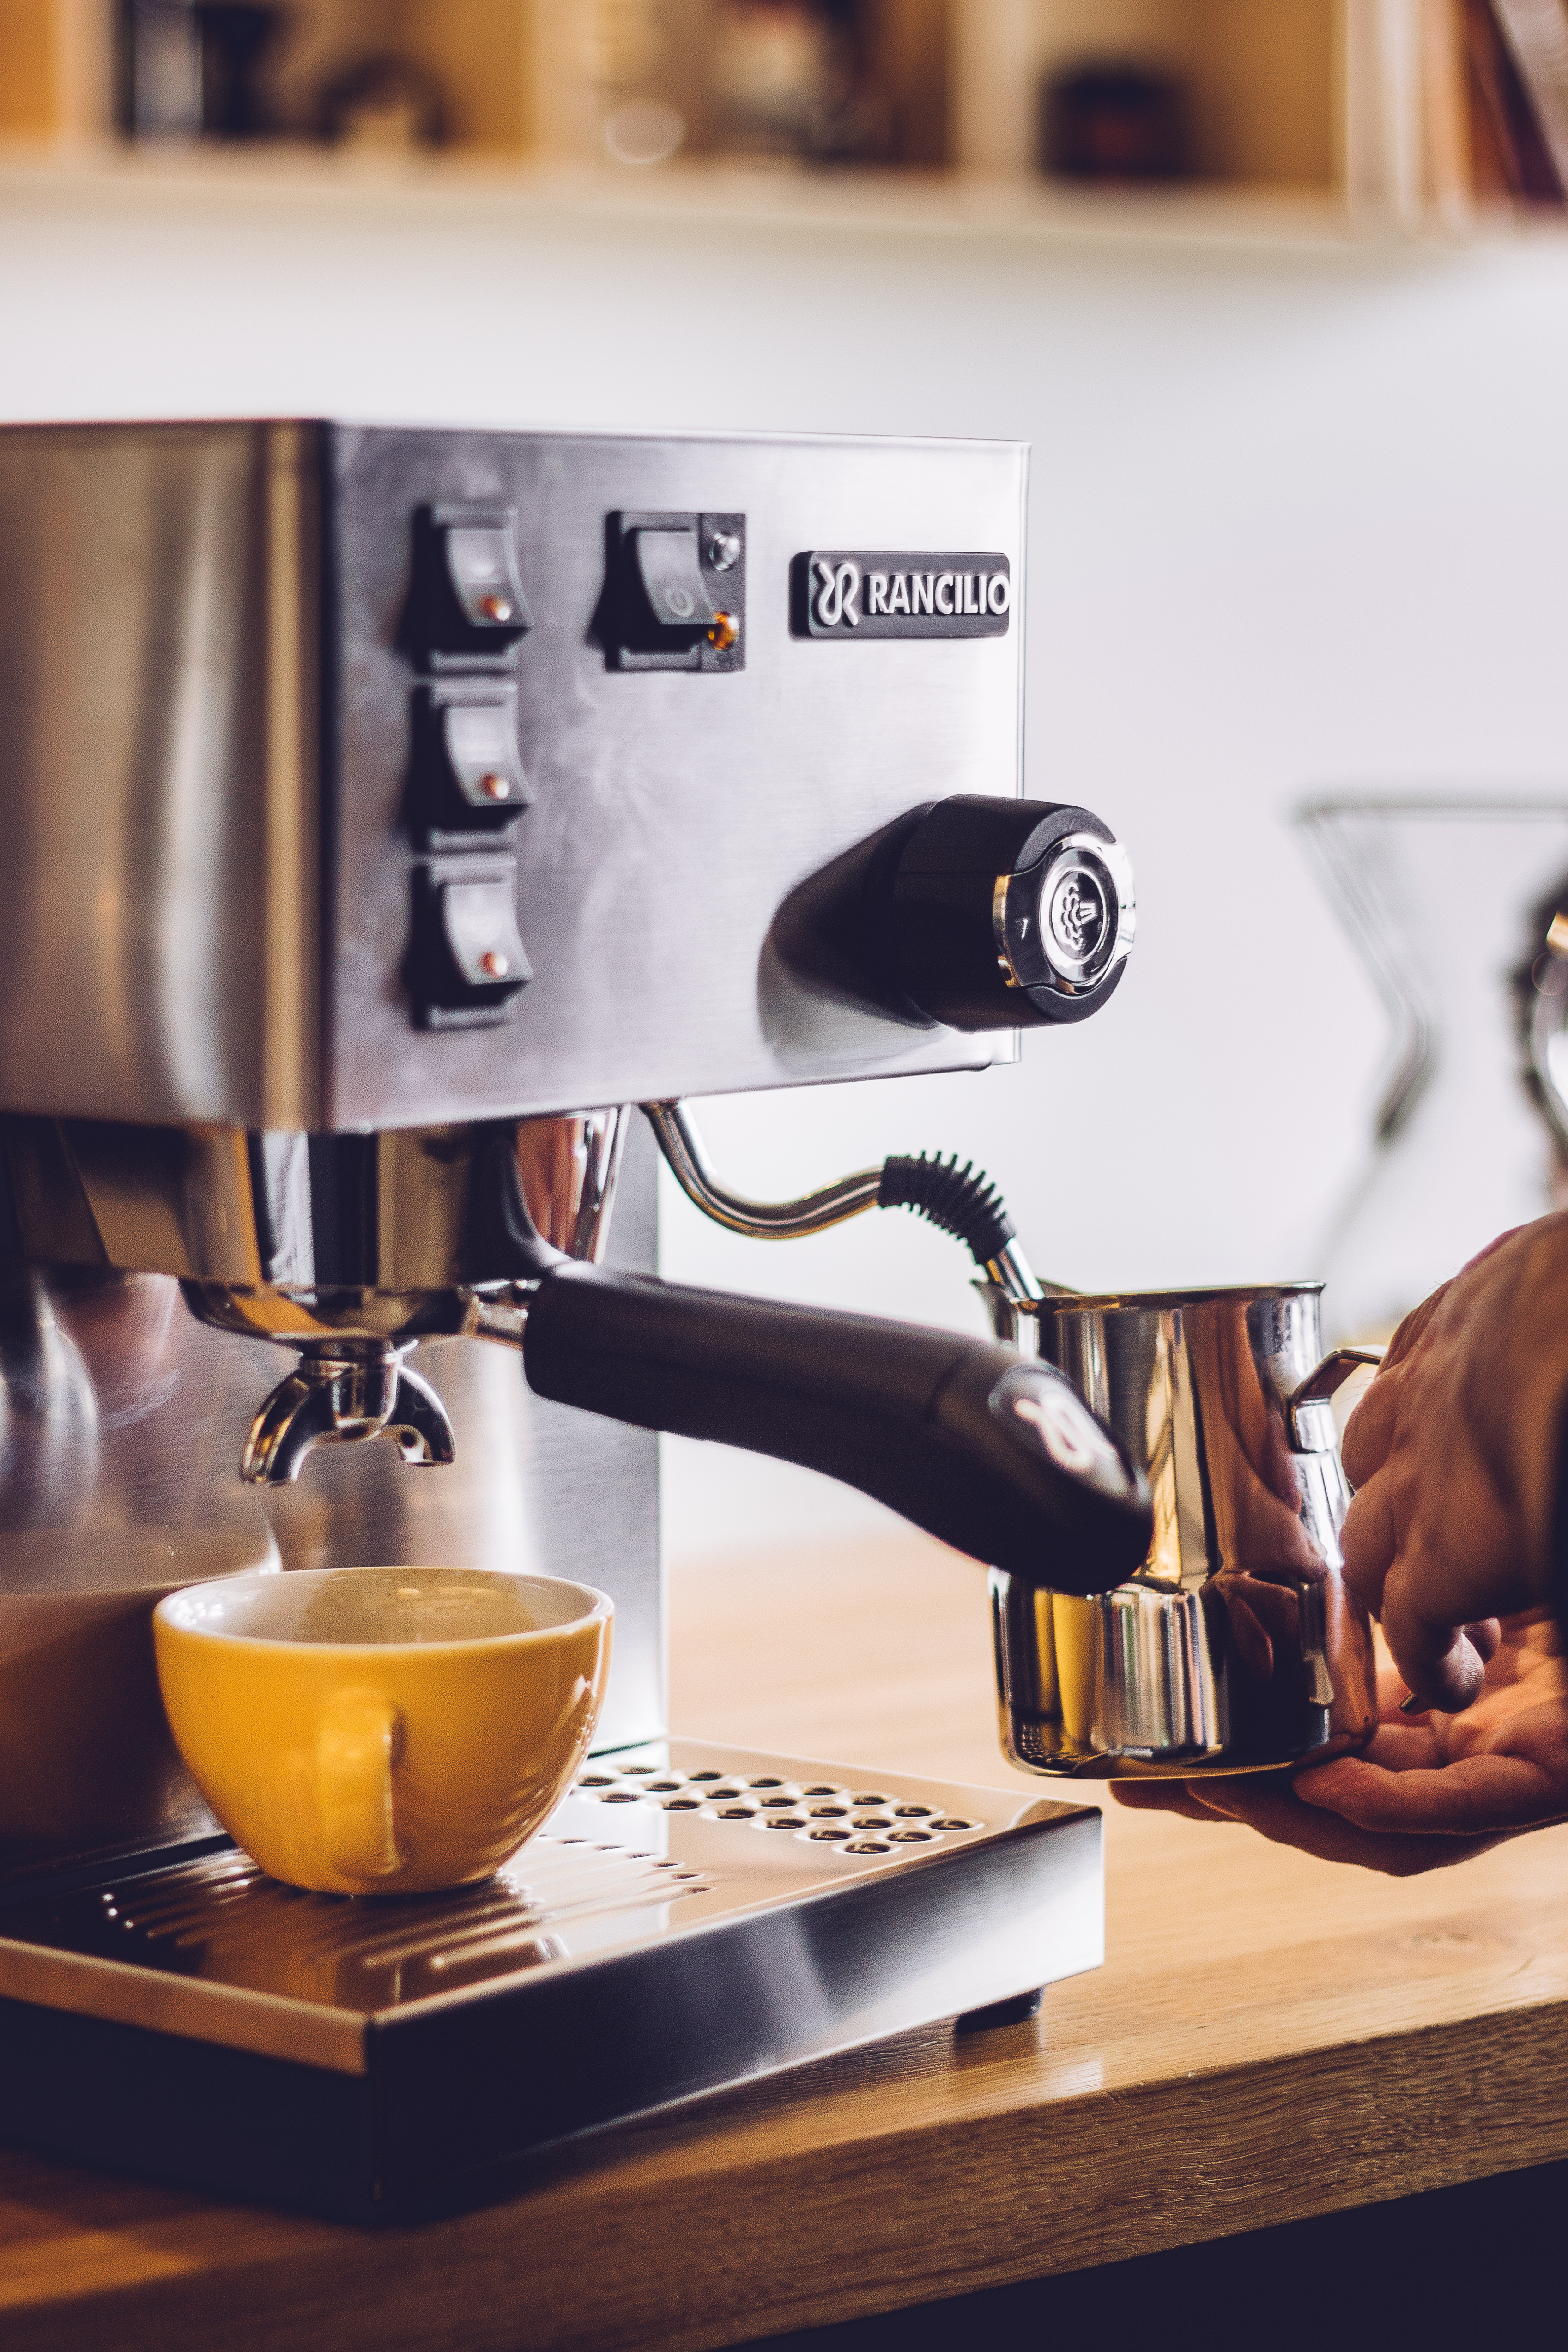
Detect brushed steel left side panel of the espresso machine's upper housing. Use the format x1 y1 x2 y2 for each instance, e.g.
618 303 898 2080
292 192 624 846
0 424 320 1127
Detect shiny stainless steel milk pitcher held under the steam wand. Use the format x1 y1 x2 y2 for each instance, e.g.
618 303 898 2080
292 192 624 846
992 1282 1375 1778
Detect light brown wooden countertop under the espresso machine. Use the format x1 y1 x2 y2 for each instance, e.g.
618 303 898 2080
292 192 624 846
0 1538 1568 2352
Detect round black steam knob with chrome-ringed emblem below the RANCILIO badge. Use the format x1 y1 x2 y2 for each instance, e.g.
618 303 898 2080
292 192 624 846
867 793 1135 1030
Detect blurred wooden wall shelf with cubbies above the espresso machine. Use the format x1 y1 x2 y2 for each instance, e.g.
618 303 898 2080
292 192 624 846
0 0 1561 249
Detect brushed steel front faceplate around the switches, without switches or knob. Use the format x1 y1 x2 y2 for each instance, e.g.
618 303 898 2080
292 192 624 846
324 426 1025 1127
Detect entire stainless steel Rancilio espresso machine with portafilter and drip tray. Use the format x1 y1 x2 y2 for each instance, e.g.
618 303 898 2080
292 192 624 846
0 421 1152 2218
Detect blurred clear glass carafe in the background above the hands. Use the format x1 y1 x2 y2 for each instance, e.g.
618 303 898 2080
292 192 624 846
1298 795 1568 1340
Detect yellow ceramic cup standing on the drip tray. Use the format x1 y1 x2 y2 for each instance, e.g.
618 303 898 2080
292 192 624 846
153 1569 613 1896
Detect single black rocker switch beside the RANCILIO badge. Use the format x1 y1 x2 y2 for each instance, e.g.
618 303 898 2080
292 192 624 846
599 513 745 670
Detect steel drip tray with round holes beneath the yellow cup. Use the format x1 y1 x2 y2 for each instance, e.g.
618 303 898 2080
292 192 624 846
0 1740 1105 2220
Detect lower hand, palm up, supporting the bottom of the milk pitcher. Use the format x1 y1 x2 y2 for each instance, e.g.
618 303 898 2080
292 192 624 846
1112 1609 1568 1877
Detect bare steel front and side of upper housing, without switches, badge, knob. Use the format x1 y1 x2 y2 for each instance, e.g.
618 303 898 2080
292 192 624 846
0 421 1025 1131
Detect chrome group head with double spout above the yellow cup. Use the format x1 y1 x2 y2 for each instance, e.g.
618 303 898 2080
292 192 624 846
0 1108 644 1484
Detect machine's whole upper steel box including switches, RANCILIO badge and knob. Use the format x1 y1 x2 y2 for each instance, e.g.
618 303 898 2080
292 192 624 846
0 416 1048 1134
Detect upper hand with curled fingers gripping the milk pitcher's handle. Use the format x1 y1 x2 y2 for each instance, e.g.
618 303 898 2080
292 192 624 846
1340 1213 1568 1710
